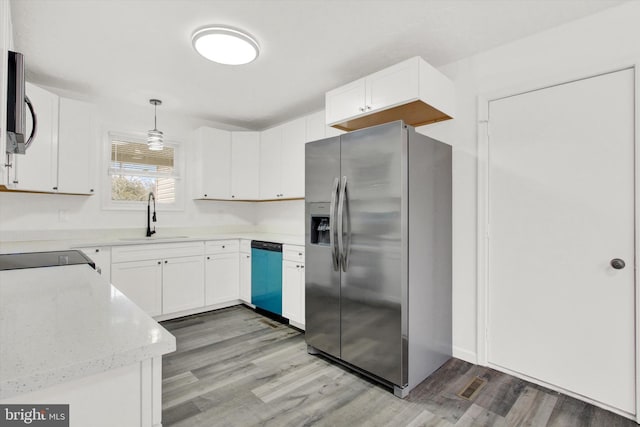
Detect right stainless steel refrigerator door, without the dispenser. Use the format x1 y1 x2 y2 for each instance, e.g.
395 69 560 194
338 122 407 386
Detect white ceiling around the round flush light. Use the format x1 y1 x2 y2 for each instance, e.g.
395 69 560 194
11 0 623 130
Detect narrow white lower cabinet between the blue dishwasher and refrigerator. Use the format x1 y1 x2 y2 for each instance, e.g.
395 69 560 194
282 245 305 329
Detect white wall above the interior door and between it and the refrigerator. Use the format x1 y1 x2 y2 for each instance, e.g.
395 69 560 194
419 2 640 362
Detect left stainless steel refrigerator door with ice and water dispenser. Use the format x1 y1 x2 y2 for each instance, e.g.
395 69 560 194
305 137 340 357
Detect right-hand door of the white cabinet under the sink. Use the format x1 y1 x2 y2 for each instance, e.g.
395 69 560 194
162 256 204 314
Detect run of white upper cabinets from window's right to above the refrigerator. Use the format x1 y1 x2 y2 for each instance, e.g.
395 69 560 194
193 111 336 201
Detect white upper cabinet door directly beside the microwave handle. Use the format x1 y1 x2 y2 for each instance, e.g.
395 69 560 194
10 83 58 192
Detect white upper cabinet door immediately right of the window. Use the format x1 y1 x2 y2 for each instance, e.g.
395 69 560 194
196 127 231 199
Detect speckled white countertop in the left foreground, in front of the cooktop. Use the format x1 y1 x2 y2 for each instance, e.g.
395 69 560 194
0 264 176 400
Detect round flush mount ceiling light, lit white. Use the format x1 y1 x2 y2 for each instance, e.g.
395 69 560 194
191 25 260 65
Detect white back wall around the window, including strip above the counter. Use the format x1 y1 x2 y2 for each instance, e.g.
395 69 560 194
0 95 255 240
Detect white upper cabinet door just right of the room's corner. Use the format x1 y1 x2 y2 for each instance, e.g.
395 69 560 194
260 126 282 200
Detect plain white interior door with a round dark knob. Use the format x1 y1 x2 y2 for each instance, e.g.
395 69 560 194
487 69 635 414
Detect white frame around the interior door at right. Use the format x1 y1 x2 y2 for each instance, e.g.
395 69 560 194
476 58 640 423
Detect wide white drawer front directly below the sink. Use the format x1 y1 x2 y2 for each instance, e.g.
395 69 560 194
111 242 204 263
